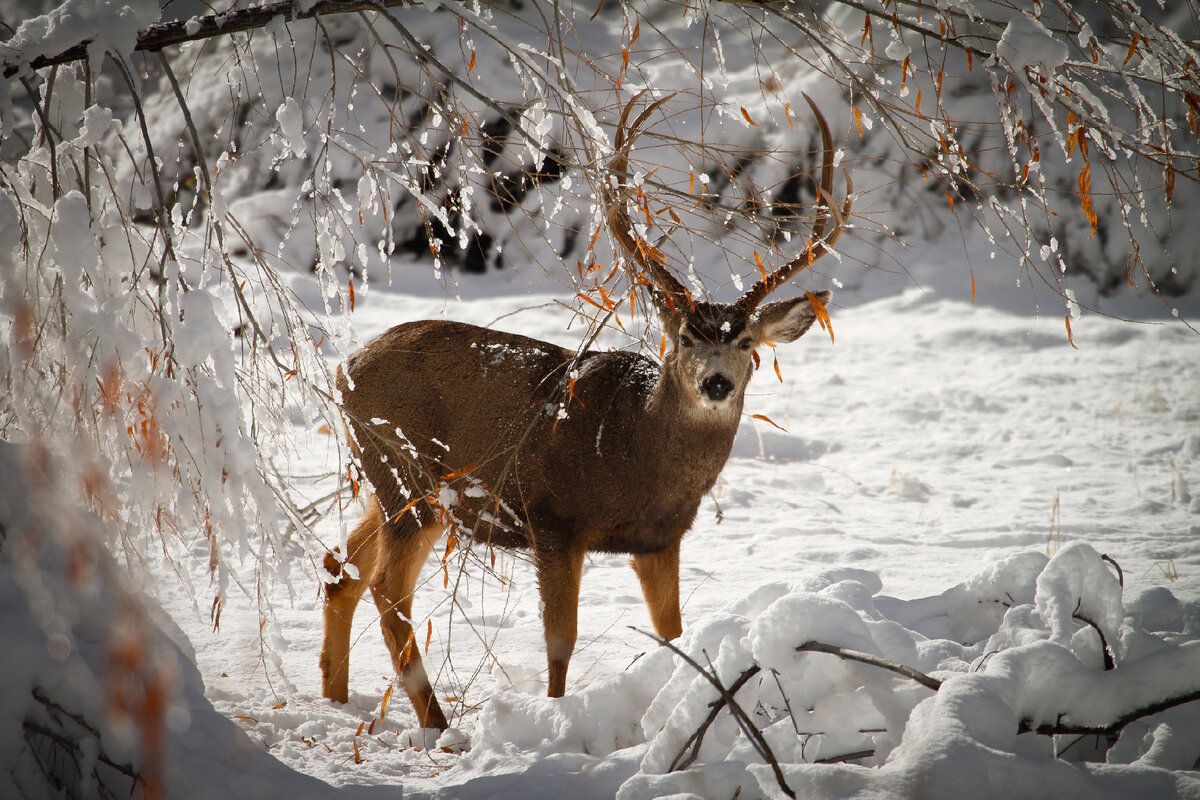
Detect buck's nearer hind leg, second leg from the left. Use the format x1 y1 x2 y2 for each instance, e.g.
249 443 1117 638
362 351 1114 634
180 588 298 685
371 521 450 730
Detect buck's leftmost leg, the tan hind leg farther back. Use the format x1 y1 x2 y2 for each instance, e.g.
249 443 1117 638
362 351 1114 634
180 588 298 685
320 498 384 703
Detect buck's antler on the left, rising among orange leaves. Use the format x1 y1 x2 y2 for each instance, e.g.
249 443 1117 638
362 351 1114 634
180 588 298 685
600 89 691 312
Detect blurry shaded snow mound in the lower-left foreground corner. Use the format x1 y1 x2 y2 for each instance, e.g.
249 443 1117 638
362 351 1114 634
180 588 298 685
0 443 335 799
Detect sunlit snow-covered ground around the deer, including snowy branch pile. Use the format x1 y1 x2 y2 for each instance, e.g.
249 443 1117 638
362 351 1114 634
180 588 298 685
152 248 1200 798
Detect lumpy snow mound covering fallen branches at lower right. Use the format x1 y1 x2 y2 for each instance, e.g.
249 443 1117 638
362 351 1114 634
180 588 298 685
460 543 1200 800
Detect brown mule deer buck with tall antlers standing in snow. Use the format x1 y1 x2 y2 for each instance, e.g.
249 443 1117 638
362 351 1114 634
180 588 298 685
320 90 853 729
